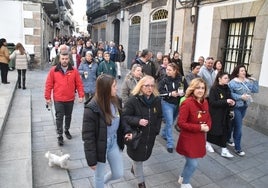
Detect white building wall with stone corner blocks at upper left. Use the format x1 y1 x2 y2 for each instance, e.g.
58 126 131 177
0 1 42 63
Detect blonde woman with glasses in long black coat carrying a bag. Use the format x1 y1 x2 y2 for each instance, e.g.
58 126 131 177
122 76 162 188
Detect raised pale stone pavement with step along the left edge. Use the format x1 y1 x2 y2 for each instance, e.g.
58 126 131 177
0 71 32 188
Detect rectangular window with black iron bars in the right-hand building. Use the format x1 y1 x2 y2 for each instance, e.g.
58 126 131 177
224 18 255 73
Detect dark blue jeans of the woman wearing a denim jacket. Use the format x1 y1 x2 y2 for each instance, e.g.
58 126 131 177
229 106 247 151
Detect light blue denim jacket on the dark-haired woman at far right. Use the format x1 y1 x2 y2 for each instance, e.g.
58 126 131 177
228 79 259 107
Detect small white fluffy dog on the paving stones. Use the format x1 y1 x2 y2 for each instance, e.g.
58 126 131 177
45 151 70 169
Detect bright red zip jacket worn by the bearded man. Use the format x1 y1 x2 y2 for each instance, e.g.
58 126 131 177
45 64 84 102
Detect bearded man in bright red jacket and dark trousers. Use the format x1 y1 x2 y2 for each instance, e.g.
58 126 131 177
45 51 84 146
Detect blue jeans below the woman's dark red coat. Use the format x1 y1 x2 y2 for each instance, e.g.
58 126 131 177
181 157 198 184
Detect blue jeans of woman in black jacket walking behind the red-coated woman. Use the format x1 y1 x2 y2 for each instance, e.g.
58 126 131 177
161 100 178 148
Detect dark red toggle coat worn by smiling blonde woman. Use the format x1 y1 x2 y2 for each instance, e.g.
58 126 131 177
176 97 211 158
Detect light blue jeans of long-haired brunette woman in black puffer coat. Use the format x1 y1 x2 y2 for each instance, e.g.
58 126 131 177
95 135 124 188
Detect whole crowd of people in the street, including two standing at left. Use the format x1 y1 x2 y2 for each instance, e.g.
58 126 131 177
0 34 259 188
